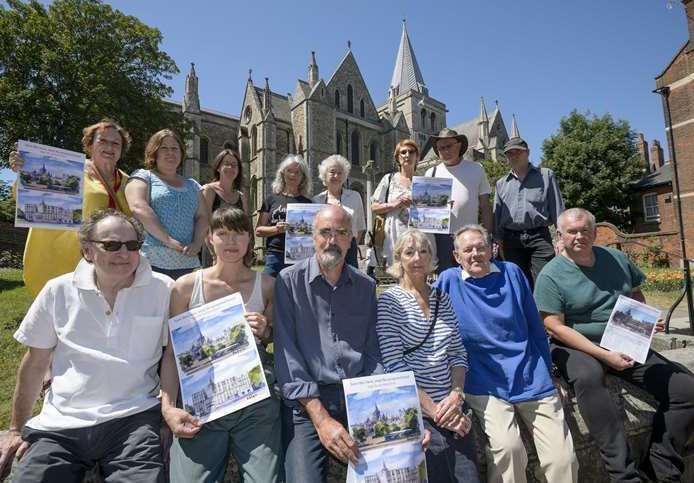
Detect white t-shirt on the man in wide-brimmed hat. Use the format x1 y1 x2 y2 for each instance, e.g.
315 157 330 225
426 159 492 234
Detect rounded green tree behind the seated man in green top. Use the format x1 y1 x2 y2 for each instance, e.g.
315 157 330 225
542 110 642 228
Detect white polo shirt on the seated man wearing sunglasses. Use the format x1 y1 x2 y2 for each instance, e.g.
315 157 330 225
14 257 173 431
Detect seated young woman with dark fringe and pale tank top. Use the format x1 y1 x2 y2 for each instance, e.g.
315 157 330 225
161 208 282 483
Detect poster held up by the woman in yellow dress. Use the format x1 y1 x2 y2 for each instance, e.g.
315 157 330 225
14 141 85 230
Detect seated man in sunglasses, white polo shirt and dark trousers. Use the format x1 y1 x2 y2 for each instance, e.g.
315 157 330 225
0 209 172 482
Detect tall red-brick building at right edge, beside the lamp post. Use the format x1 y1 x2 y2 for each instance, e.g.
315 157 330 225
655 0 694 257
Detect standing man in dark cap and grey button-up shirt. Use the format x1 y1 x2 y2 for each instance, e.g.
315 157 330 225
494 137 564 287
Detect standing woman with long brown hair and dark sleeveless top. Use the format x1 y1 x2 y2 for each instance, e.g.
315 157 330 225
202 149 248 267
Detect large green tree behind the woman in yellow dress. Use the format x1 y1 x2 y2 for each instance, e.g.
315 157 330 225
0 0 185 171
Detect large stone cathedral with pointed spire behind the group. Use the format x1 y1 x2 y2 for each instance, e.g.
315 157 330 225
167 21 518 221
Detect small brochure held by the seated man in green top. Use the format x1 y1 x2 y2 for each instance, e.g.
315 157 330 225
600 295 661 364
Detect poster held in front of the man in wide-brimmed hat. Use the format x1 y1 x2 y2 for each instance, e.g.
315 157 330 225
409 176 453 233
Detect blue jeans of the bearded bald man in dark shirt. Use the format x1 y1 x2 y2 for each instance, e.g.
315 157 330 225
282 384 348 483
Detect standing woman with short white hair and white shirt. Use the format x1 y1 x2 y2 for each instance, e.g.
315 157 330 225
313 154 366 268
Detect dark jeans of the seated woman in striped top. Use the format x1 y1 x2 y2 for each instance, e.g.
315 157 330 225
424 418 480 483
